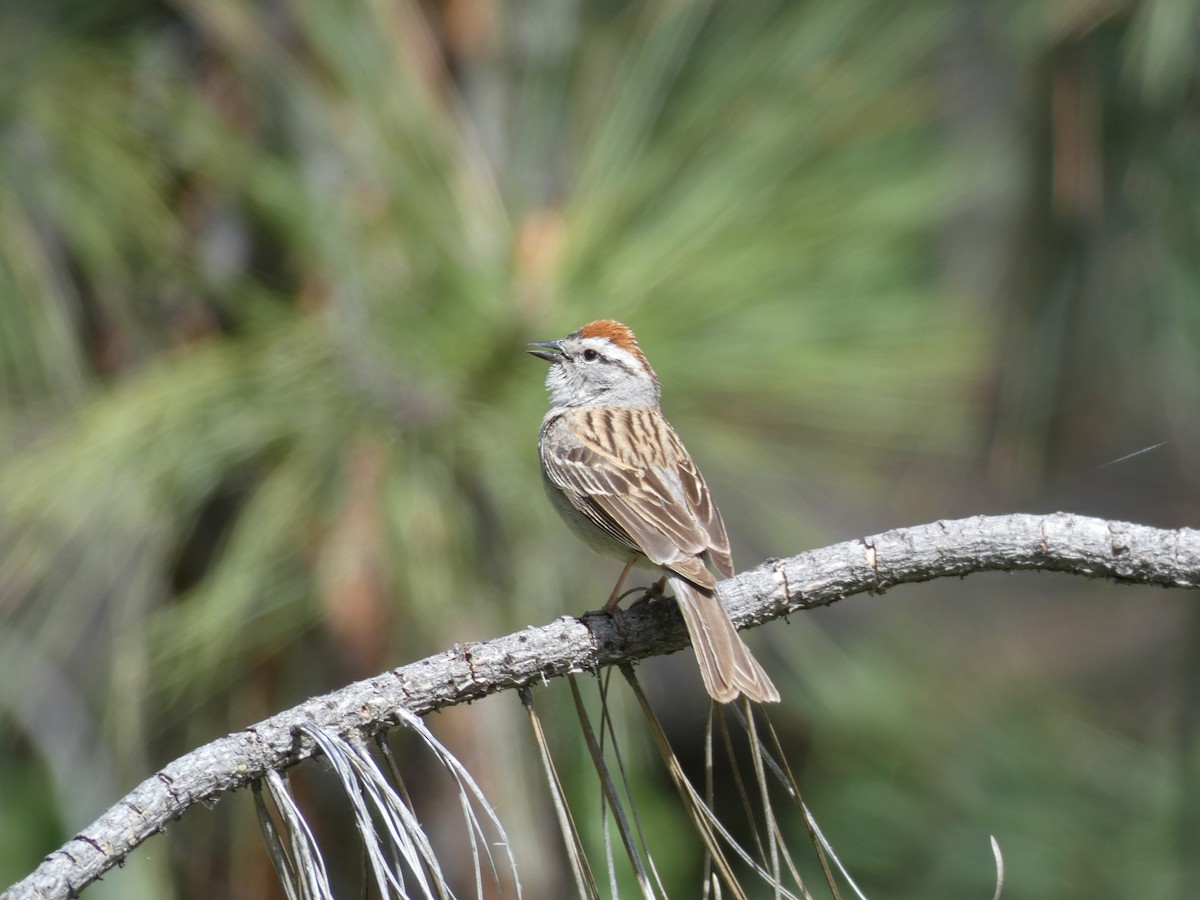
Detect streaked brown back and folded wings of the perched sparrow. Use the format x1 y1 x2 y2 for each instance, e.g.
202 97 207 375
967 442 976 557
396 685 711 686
544 407 733 586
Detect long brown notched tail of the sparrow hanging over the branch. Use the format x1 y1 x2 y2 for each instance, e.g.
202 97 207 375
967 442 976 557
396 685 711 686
668 575 779 703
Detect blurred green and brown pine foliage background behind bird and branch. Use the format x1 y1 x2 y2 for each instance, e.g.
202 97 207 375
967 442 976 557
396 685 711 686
0 0 1200 898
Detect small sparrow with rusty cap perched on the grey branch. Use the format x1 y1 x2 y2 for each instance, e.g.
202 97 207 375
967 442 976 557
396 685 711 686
529 319 779 703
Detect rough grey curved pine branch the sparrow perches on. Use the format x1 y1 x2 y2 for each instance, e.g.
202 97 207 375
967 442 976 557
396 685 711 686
0 512 1200 900
